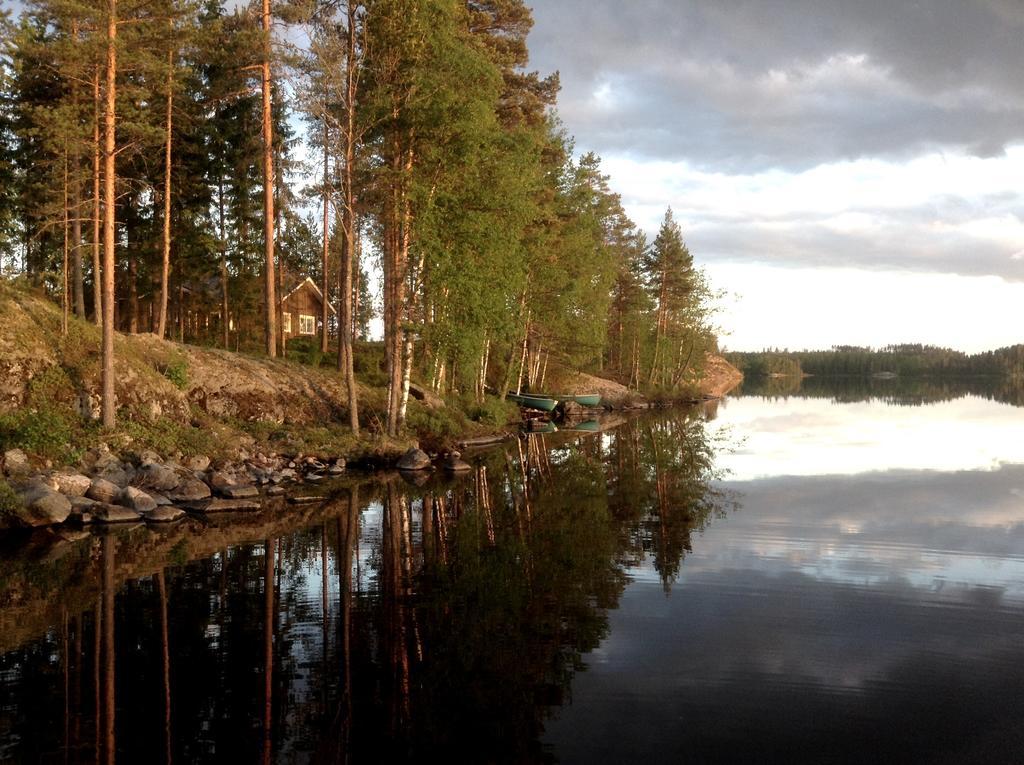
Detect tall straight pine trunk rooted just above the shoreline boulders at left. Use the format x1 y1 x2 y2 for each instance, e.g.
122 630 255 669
102 0 118 430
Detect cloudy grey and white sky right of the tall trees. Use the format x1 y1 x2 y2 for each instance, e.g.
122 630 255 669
529 0 1024 351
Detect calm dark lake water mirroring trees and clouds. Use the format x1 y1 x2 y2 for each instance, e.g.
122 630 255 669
0 386 1024 763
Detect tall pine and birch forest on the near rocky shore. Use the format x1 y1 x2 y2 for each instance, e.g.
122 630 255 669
0 0 717 435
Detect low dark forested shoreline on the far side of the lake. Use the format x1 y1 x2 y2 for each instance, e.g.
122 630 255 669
727 345 1024 379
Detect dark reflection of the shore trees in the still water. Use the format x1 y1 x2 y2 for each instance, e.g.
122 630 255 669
0 412 731 763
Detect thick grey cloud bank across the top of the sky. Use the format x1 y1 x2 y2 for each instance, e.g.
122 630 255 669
531 0 1024 172
